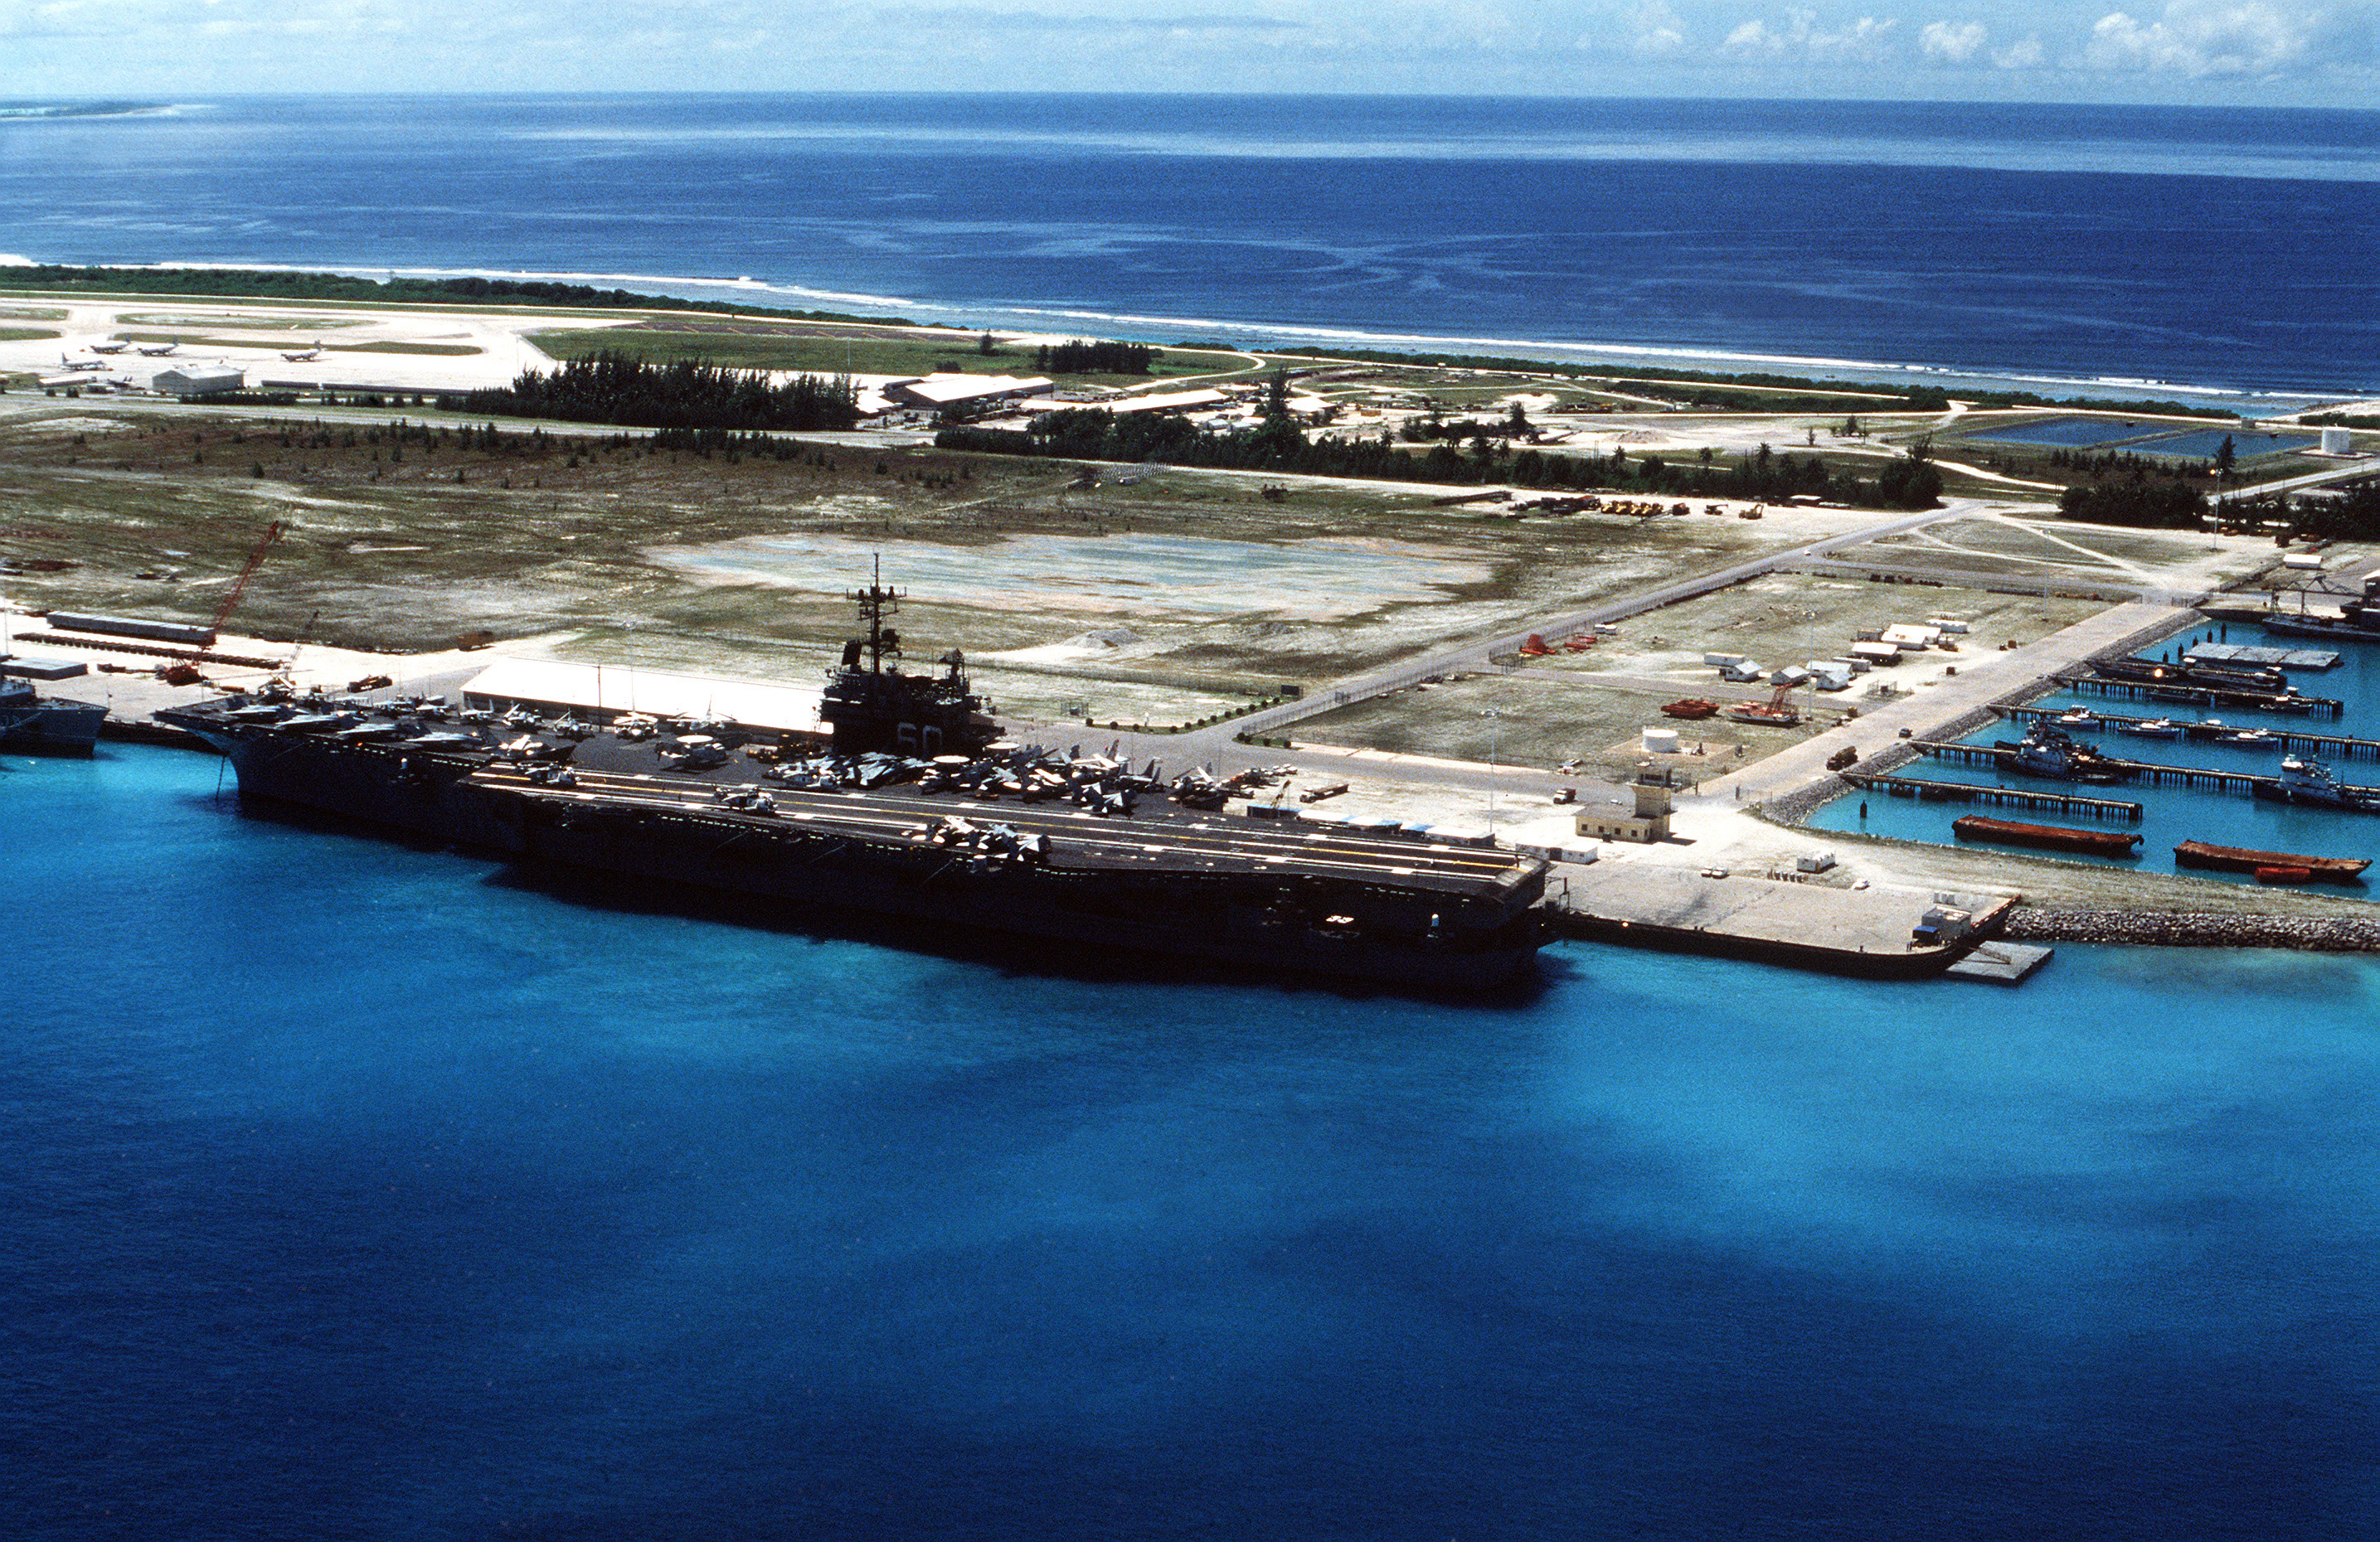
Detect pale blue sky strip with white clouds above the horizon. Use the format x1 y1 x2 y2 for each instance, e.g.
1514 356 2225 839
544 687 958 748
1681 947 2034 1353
0 0 2380 107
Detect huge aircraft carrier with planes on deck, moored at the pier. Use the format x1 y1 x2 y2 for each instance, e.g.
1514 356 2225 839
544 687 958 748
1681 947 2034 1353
157 583 1547 990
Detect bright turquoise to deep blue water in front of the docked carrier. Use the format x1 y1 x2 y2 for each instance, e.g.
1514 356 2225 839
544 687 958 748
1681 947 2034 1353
0 747 2380 1542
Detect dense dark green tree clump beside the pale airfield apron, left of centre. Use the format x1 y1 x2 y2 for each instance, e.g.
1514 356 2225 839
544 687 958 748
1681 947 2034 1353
438 350 859 431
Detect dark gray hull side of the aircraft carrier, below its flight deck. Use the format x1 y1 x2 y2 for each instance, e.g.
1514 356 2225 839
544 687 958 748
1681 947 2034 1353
195 716 1545 990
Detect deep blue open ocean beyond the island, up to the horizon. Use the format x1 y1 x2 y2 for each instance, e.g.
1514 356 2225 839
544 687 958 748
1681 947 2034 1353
0 95 2380 397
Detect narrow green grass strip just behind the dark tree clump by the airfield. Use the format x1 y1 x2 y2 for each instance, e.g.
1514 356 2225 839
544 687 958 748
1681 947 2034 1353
528 323 1259 386
